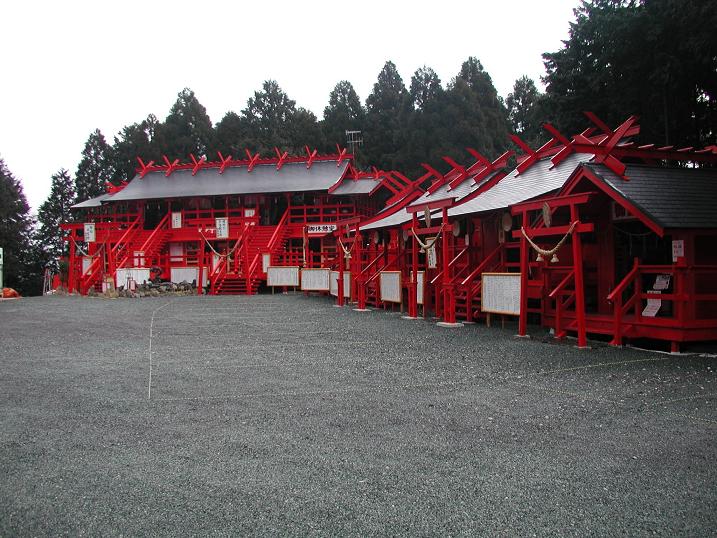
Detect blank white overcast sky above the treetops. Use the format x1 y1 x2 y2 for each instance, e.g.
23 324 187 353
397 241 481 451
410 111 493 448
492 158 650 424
0 0 578 211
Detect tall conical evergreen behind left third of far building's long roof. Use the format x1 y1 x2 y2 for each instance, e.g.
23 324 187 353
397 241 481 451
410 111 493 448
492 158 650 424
157 88 214 162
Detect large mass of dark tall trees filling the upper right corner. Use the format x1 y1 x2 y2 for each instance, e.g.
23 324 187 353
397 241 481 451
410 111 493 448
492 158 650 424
543 0 717 146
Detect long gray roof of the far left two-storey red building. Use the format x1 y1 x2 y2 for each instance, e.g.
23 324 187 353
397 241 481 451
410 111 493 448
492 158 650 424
106 161 349 202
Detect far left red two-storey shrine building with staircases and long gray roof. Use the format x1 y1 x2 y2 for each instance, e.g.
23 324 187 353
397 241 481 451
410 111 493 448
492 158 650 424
62 148 390 294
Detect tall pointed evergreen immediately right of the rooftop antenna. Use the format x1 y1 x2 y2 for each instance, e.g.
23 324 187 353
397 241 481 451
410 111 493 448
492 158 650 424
363 61 413 169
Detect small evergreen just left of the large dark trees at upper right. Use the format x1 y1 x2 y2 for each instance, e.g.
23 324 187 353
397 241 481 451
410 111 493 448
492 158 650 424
505 76 548 147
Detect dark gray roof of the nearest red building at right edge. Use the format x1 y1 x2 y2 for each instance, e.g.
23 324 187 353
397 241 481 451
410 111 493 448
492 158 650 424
585 163 717 228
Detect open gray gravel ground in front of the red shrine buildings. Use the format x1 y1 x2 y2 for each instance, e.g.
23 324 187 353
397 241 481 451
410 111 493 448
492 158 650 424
0 295 717 536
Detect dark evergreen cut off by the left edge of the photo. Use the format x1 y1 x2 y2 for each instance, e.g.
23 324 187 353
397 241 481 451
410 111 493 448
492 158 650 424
0 158 42 295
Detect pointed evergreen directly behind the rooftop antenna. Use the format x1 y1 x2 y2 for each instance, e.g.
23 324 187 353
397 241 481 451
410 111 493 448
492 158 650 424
322 80 366 151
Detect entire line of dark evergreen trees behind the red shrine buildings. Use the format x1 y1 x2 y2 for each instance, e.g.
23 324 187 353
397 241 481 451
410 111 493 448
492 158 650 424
0 0 717 293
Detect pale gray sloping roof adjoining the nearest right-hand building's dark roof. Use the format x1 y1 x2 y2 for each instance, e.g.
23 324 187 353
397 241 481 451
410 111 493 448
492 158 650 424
448 153 593 217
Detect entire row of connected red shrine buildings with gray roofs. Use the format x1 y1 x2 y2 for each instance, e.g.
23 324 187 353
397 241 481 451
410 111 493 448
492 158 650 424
64 113 717 351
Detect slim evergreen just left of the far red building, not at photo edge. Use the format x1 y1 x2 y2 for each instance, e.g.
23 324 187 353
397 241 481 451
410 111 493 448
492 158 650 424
36 168 75 269
